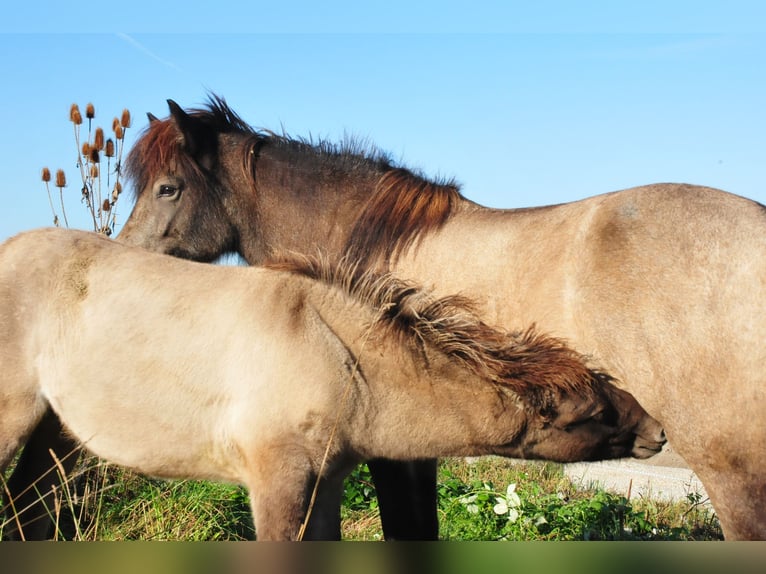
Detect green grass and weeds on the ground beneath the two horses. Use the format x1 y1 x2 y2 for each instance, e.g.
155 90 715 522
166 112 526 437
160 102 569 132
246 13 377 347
6 457 722 540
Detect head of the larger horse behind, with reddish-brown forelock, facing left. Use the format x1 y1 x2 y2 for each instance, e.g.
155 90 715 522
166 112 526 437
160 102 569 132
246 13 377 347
118 100 244 261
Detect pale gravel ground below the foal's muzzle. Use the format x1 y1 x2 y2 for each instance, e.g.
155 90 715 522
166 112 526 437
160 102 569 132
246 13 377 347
564 445 707 506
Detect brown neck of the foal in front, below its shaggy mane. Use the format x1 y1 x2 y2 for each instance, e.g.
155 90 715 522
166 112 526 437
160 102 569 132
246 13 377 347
314 293 521 459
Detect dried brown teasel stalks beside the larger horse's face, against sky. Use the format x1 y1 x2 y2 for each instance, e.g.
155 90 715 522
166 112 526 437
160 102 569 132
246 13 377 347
42 103 131 236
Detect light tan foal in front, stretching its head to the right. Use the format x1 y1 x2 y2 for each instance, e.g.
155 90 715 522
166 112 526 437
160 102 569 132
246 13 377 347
0 229 664 540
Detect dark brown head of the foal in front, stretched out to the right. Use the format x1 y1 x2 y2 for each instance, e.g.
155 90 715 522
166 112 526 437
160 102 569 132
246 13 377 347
510 375 666 462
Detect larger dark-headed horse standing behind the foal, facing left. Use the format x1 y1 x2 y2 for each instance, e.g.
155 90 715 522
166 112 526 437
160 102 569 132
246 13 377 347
12 98 766 539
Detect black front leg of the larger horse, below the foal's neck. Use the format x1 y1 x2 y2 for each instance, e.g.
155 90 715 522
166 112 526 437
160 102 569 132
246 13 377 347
367 459 439 540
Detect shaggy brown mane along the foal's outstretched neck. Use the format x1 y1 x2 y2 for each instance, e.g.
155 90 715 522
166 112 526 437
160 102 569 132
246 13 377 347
268 256 609 395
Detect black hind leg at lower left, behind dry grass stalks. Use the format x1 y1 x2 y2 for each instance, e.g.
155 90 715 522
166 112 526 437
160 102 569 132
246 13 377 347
4 409 80 540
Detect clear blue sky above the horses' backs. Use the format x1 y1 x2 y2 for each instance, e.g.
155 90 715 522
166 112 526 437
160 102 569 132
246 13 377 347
0 0 766 240
